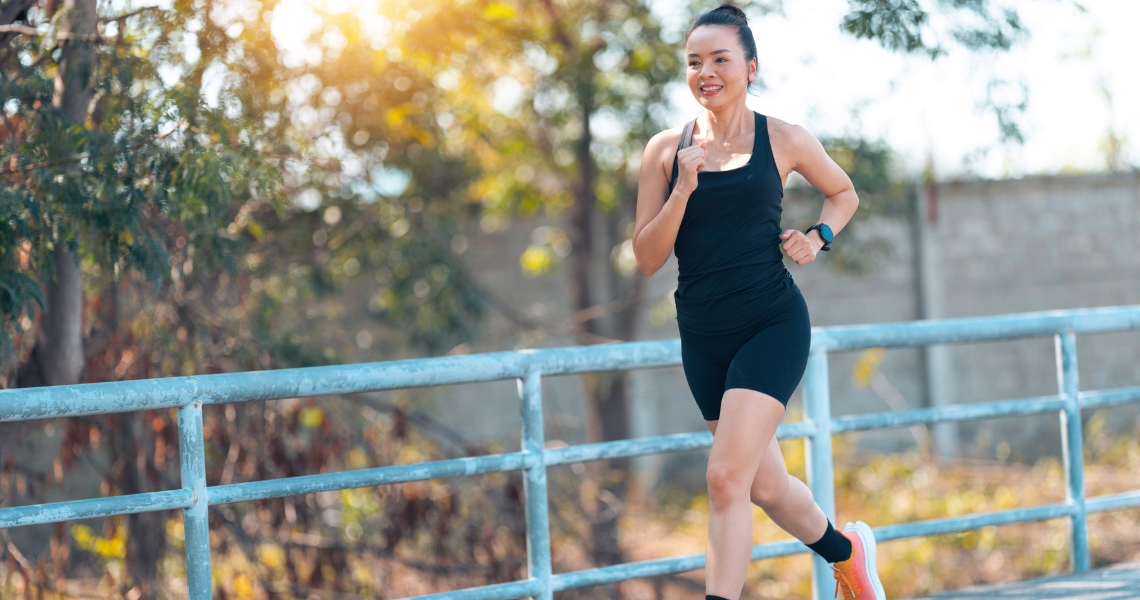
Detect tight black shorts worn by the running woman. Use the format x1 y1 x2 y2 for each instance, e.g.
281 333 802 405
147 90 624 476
681 293 812 421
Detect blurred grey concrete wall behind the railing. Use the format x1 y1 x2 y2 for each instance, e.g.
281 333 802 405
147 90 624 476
430 173 1140 485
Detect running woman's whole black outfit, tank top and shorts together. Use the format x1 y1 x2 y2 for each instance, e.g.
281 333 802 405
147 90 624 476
673 113 812 421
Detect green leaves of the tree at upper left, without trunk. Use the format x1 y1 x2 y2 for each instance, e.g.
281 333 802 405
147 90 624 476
0 0 284 369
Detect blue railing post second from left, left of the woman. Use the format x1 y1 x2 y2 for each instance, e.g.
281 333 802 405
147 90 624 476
519 371 554 600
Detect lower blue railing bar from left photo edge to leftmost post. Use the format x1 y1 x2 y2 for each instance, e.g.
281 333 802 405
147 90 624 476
0 488 194 529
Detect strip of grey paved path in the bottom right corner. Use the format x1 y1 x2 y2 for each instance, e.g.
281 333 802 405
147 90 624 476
915 562 1140 600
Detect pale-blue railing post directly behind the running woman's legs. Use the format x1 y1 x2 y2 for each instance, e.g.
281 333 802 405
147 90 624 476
804 348 839 600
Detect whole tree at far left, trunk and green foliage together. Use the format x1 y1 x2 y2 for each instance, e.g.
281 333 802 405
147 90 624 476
0 0 284 598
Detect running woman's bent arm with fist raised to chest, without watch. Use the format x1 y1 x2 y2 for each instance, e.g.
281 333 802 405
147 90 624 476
633 131 705 275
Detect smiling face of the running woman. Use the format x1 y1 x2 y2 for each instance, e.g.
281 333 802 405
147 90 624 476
685 25 756 110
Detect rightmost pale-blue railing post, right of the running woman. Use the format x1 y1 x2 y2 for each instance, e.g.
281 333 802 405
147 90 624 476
1057 331 1089 573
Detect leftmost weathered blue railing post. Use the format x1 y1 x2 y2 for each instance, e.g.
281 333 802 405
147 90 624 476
178 400 213 600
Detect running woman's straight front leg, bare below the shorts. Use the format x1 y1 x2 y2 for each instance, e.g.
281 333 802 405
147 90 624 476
705 388 788 600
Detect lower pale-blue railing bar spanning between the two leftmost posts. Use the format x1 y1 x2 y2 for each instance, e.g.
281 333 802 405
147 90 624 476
207 452 538 505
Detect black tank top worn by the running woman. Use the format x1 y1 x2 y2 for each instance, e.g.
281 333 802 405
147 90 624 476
673 113 799 334
